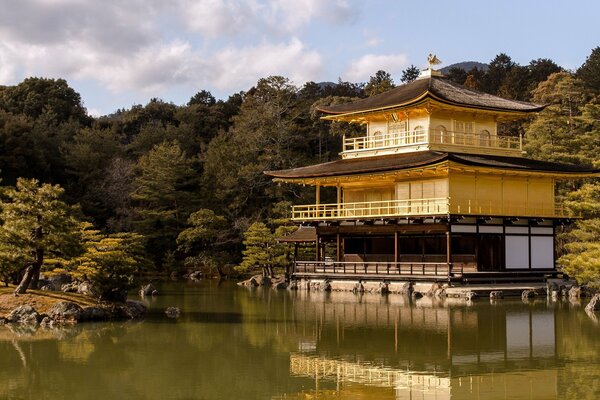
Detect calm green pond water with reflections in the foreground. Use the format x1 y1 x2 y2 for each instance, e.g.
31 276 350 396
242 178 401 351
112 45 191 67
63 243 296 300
0 282 600 400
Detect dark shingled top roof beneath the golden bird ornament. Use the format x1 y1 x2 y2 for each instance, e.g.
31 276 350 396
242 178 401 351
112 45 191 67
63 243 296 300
319 76 545 114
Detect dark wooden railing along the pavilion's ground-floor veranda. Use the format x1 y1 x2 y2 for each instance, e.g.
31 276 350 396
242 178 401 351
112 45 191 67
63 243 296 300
294 261 454 279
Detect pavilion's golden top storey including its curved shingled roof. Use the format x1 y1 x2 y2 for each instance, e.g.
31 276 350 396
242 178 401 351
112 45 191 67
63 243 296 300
320 70 544 158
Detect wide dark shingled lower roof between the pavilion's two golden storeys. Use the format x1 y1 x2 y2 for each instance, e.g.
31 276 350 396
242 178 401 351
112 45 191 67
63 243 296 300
265 151 600 179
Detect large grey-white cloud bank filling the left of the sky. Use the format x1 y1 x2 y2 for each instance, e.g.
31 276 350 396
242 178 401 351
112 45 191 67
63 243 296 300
0 0 360 104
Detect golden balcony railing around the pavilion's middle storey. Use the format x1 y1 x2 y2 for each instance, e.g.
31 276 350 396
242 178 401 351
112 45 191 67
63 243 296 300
292 197 574 221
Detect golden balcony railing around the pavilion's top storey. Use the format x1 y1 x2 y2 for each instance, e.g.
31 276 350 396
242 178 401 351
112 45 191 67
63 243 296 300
343 129 523 153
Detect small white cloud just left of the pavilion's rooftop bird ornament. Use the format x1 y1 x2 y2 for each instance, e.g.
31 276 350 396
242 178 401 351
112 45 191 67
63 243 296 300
343 53 408 82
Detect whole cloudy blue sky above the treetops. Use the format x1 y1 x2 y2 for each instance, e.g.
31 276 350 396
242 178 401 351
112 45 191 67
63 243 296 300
0 0 600 115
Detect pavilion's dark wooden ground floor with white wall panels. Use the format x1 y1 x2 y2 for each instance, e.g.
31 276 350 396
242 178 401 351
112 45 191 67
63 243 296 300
291 216 568 282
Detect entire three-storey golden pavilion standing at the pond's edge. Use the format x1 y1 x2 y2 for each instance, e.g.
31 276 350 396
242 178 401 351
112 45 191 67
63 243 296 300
265 60 598 282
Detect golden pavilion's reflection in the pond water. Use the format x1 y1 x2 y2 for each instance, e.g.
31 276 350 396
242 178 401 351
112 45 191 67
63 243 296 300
290 293 558 399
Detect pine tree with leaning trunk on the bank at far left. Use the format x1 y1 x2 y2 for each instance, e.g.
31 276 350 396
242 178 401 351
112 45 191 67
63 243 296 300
0 179 80 293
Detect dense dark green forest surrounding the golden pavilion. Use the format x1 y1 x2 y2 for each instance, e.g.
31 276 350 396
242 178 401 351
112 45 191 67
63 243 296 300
0 47 600 290
